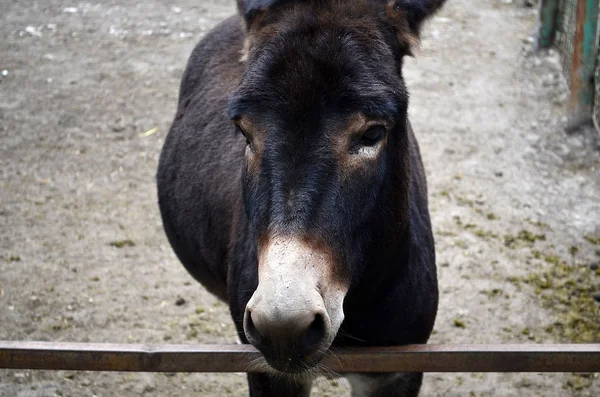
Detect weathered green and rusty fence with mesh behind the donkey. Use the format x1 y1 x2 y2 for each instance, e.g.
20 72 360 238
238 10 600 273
536 0 600 127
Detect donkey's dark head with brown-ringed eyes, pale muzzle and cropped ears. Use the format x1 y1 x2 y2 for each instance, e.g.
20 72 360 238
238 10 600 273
229 0 441 373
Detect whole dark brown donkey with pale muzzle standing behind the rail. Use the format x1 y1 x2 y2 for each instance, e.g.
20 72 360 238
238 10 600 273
158 0 444 397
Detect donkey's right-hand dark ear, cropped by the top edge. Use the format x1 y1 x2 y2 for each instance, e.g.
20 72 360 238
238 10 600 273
386 0 446 55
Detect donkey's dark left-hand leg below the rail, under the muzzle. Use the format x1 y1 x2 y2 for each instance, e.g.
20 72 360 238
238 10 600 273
248 374 312 397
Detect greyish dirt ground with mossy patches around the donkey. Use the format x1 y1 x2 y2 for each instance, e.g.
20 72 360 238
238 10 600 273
0 0 600 397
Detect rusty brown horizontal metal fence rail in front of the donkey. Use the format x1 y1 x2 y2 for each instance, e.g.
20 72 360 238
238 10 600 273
0 341 600 373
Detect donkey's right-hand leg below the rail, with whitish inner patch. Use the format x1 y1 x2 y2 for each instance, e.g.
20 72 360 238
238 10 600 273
347 372 423 397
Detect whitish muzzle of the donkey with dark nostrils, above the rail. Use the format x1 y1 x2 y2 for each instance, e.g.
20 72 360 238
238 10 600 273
244 237 347 373
